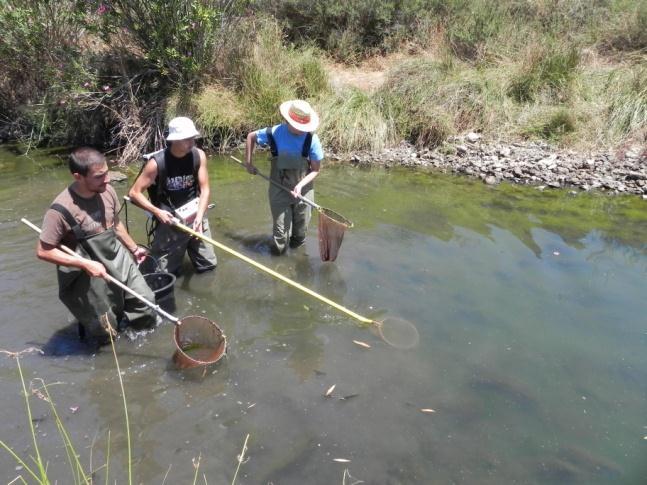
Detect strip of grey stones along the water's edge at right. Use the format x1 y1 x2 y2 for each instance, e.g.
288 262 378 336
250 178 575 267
340 133 647 199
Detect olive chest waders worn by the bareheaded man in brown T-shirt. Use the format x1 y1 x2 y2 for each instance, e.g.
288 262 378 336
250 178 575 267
52 204 155 341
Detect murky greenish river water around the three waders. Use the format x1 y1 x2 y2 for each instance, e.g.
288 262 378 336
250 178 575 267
0 148 647 484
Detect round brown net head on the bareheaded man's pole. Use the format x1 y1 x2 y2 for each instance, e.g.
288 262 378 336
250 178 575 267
173 315 227 369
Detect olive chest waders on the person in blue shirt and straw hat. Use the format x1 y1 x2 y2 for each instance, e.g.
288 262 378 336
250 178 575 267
266 128 314 253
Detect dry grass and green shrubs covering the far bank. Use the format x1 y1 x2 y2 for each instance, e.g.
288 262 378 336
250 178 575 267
0 0 647 160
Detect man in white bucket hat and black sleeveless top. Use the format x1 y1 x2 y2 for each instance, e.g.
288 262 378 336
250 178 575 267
128 117 217 274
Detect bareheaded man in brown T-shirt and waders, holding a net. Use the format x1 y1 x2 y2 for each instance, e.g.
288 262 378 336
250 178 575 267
37 148 155 343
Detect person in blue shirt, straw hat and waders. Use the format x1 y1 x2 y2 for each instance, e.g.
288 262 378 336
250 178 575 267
245 100 324 254
